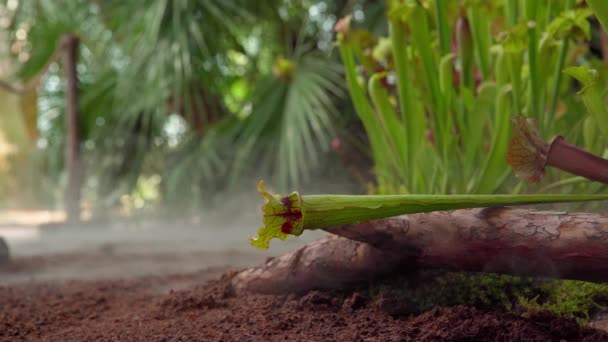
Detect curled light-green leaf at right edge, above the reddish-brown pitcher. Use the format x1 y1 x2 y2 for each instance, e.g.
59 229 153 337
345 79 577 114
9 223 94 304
564 66 608 139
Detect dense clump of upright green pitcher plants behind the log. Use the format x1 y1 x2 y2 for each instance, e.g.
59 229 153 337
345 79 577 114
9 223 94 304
337 0 608 194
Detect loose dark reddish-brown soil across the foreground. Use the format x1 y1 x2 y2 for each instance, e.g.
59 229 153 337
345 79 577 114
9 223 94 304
0 270 608 341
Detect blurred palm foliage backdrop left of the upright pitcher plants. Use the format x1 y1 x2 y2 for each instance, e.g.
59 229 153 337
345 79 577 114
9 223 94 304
0 0 382 216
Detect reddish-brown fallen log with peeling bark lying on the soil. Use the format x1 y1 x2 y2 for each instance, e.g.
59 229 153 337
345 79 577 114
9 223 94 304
233 207 608 293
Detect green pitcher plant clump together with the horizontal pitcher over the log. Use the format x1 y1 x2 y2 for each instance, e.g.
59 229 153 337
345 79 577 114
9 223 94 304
250 0 608 249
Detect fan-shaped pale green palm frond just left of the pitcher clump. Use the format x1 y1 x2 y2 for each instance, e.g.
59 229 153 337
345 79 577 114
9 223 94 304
232 52 343 187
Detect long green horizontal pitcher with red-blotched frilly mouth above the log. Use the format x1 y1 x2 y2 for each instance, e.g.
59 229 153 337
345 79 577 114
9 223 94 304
250 182 608 249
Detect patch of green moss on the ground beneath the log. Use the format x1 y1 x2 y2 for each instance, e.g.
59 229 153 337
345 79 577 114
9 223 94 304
360 270 608 324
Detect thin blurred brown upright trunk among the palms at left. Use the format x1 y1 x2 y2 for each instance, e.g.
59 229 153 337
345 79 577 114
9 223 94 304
61 35 83 221
